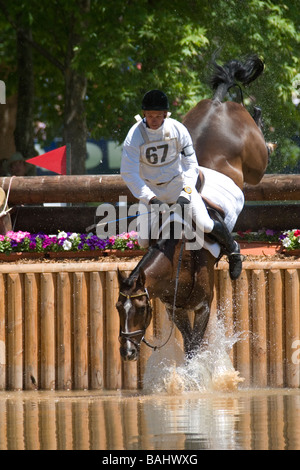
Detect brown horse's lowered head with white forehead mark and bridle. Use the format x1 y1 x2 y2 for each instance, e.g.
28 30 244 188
116 270 152 361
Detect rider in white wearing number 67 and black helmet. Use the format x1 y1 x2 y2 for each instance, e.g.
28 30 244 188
121 90 242 279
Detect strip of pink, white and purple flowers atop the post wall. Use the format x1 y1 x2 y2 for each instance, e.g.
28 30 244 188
0 229 300 261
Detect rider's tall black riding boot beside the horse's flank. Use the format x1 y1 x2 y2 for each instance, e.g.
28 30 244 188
210 220 243 280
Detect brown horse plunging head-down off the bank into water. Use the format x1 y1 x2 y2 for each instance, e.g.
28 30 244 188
116 56 269 361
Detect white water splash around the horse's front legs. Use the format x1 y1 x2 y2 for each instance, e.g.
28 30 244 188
144 320 244 395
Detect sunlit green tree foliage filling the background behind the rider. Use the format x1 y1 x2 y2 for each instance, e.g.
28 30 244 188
0 0 300 171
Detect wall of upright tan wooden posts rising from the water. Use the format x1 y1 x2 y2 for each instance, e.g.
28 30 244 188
0 260 300 390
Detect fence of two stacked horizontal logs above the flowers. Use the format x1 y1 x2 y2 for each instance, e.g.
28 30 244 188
0 175 300 233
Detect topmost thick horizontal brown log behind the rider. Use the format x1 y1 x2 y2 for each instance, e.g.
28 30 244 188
0 175 300 205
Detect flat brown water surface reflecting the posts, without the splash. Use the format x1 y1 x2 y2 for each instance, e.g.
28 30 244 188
0 390 300 451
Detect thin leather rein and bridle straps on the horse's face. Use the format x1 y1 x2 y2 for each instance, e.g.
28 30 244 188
120 239 184 351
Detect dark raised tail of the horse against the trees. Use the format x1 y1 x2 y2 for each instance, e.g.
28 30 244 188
210 55 264 101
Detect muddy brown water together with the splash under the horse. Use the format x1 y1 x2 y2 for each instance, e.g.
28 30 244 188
0 327 300 452
